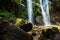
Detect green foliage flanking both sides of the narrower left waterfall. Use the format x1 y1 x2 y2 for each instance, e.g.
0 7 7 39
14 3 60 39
20 0 40 19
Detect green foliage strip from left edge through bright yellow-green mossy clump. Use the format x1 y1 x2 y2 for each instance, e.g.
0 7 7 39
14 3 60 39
0 10 27 26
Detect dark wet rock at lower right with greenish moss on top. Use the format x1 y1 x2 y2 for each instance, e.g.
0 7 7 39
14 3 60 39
40 27 59 40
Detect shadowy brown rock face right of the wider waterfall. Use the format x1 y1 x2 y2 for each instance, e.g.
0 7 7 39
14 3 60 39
50 0 60 25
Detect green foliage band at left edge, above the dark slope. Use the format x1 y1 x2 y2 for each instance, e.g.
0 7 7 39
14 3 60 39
0 10 16 23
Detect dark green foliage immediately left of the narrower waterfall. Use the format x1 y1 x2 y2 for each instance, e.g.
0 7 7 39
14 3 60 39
20 0 28 19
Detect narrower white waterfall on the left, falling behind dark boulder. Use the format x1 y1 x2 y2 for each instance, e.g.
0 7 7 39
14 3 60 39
27 0 33 24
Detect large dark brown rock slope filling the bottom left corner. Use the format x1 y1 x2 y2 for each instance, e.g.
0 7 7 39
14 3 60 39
0 21 33 40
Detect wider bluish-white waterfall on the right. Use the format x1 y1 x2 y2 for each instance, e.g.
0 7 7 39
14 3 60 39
40 0 51 26
